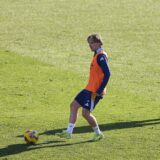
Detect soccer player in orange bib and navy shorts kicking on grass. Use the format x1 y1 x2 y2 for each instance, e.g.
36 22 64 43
56 34 110 141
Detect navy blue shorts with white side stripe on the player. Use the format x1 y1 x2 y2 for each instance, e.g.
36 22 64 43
75 89 102 111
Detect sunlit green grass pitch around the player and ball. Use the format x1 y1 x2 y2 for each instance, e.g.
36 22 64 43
0 0 160 160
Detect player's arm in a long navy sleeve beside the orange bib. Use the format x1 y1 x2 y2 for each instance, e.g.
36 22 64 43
96 54 110 96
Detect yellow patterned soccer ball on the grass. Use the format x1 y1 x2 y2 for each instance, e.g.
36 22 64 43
24 130 39 144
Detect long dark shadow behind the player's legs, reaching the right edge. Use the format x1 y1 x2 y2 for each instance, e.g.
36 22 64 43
41 118 160 135
